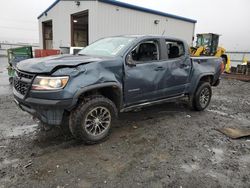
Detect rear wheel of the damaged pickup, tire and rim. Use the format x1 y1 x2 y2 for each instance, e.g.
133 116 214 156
192 82 212 111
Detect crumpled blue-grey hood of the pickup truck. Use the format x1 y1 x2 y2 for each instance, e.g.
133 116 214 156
17 55 102 73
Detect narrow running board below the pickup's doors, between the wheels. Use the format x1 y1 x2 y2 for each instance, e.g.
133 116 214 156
120 94 185 112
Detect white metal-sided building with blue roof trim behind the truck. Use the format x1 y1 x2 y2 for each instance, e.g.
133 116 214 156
38 0 196 49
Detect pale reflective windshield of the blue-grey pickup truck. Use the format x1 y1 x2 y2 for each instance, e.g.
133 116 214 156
78 37 135 57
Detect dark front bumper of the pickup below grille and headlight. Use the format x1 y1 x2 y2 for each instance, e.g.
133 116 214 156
13 88 73 125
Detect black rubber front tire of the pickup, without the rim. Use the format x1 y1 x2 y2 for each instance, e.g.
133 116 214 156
69 95 117 144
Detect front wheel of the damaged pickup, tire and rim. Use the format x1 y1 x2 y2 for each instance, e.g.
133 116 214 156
69 96 117 144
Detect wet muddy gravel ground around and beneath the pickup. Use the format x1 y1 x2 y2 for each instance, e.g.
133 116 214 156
0 58 250 188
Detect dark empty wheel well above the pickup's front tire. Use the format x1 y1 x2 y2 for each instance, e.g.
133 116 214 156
78 86 122 109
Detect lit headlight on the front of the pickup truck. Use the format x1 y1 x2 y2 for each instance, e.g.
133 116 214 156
32 76 69 90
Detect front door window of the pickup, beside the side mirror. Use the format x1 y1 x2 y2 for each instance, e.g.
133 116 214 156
131 40 160 63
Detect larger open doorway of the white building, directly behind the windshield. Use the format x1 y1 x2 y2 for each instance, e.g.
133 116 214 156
71 11 89 47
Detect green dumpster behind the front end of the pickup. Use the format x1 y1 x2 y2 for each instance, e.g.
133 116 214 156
7 46 33 84
